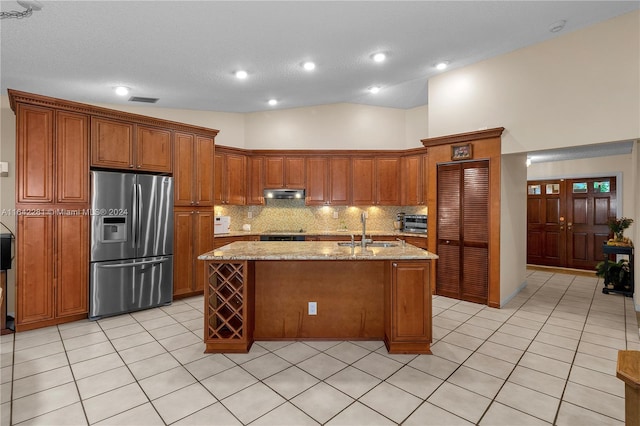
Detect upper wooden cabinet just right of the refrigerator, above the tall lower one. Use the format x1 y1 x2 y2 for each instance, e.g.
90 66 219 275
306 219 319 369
173 132 214 206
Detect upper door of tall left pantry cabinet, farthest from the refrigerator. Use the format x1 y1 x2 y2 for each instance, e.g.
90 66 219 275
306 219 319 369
16 104 53 203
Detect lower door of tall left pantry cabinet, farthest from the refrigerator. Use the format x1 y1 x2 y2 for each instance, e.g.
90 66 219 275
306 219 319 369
16 215 53 324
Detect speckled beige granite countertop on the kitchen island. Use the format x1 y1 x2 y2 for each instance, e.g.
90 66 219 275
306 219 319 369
198 241 438 260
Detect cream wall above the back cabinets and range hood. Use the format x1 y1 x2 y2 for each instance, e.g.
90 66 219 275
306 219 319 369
245 103 410 149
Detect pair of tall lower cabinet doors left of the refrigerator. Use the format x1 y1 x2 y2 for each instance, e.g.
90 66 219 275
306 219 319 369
16 214 89 331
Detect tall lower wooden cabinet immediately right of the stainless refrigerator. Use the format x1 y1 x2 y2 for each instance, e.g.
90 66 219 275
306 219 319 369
173 208 213 298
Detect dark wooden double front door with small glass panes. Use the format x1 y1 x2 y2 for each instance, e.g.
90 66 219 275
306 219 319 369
527 177 617 270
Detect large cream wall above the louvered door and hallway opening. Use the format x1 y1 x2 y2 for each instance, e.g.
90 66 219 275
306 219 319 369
429 11 640 154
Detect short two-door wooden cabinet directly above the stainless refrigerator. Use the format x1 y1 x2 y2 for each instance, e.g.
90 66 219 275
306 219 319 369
91 117 172 173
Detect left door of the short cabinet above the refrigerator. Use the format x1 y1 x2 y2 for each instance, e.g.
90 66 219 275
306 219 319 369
91 117 135 169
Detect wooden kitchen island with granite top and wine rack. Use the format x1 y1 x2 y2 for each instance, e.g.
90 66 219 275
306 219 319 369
198 241 437 354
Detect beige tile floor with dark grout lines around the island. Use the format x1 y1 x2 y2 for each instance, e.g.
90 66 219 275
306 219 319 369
0 270 640 425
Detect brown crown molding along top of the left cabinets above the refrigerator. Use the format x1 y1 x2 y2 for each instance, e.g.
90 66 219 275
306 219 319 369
7 89 219 137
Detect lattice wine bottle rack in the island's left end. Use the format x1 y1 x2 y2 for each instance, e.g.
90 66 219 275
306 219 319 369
207 263 246 340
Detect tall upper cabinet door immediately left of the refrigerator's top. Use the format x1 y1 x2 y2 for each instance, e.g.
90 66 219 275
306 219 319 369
56 111 89 204
